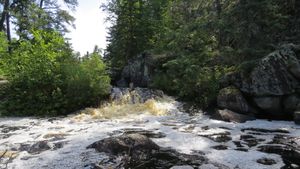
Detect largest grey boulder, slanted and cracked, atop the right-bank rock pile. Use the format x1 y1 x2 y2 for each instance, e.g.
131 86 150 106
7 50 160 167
225 44 300 96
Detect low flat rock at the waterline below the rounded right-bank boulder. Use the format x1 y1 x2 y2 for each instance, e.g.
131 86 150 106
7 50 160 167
212 109 255 123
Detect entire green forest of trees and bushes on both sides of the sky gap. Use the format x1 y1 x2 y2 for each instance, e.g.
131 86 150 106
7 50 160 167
0 0 300 116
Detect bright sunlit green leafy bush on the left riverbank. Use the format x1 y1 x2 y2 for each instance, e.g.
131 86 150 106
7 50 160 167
1 31 110 116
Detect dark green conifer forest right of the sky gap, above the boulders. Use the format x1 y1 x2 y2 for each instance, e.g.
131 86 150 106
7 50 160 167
103 0 300 107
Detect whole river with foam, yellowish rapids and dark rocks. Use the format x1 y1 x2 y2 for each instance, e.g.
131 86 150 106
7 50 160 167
0 92 300 169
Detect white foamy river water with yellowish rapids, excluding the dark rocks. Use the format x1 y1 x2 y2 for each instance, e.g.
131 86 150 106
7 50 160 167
0 100 300 169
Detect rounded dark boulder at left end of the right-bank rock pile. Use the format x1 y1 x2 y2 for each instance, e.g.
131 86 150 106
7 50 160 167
217 86 250 113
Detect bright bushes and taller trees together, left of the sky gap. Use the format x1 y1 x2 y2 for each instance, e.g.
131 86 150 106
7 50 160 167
0 0 110 116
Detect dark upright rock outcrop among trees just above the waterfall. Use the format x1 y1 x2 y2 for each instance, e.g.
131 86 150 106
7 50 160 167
117 53 154 87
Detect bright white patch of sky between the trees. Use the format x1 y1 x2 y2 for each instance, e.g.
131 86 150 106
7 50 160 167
67 0 108 54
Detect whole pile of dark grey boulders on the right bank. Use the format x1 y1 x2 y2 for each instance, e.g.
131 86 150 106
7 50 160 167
218 44 300 122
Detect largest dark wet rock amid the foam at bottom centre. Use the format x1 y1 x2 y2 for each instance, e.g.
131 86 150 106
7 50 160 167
87 134 206 169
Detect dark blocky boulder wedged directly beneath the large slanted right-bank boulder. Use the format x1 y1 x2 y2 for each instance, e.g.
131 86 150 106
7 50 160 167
253 96 282 115
